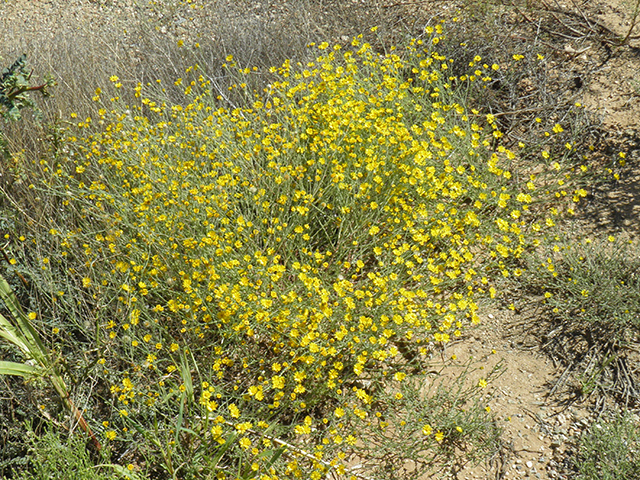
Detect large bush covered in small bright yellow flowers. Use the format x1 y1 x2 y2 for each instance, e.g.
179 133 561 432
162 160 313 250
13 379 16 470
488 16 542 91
2 26 586 479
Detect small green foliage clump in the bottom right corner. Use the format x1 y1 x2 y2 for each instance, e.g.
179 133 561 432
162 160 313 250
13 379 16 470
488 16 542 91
576 413 640 480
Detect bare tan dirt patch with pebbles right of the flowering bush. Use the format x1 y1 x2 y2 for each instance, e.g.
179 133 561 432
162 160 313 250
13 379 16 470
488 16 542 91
447 310 591 479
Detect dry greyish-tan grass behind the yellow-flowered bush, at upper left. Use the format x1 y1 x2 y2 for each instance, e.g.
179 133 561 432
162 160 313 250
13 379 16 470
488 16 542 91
0 0 412 159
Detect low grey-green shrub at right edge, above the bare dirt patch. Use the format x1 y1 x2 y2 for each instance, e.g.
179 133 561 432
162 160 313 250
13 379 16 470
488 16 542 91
516 236 640 405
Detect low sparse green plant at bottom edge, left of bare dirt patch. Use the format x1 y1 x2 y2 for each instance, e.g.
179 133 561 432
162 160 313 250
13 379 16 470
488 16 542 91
348 360 502 474
